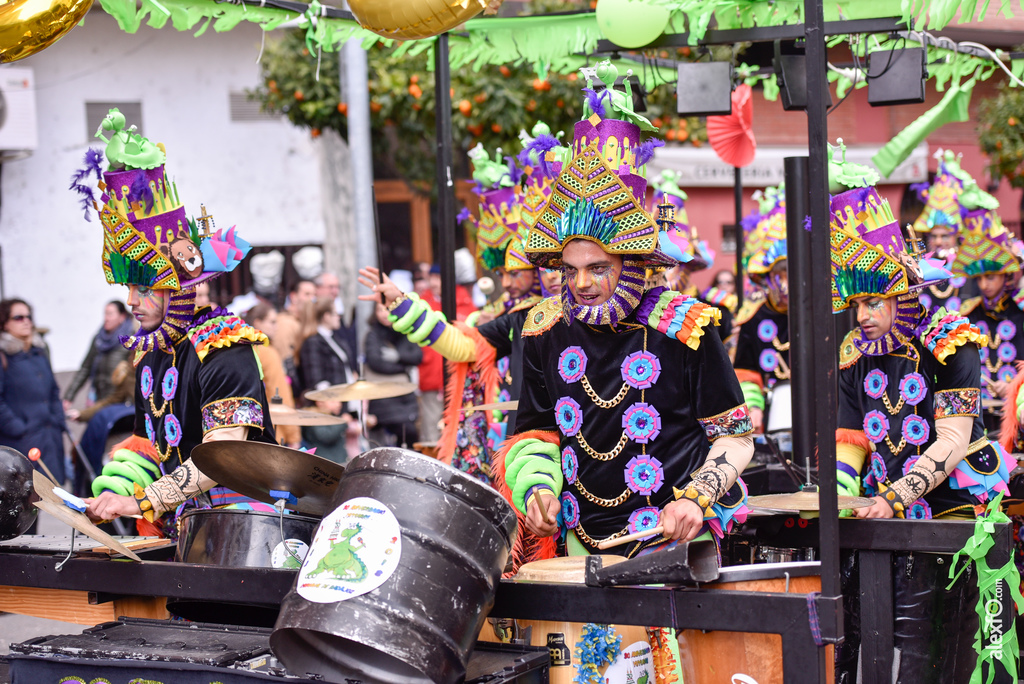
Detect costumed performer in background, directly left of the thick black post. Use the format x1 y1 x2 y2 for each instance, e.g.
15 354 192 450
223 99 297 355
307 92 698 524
733 186 790 432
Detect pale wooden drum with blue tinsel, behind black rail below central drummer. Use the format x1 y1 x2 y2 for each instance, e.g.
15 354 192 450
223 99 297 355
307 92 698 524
480 556 654 684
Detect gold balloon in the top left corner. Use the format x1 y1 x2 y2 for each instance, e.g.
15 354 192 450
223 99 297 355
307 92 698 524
0 0 92 61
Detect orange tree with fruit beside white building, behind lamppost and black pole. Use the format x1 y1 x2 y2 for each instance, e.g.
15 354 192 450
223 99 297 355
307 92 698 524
249 23 707 191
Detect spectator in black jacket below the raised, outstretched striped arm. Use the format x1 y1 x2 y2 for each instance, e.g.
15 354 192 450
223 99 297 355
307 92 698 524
364 303 423 446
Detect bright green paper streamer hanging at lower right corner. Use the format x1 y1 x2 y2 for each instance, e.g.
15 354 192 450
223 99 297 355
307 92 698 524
946 491 1024 684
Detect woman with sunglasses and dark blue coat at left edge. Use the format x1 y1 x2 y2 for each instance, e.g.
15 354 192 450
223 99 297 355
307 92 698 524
0 299 65 484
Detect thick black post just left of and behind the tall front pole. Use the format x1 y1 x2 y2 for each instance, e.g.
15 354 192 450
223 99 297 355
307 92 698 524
784 157 816 485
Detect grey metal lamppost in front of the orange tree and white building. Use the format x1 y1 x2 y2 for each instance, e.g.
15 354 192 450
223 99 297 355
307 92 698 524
339 40 384 356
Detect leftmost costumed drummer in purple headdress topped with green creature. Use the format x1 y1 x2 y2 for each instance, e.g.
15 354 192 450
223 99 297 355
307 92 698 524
72 109 274 533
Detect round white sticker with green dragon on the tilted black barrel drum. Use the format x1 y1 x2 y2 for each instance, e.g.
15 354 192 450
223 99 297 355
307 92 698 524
296 497 401 603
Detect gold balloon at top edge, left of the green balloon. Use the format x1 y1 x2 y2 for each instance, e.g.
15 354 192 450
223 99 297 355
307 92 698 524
348 0 500 40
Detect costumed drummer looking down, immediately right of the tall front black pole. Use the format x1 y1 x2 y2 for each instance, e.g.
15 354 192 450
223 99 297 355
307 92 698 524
831 166 1015 682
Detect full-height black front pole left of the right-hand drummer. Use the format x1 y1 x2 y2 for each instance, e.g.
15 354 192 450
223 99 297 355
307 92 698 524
791 0 843 655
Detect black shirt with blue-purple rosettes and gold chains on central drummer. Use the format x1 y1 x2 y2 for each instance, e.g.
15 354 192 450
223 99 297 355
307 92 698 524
516 291 752 551
